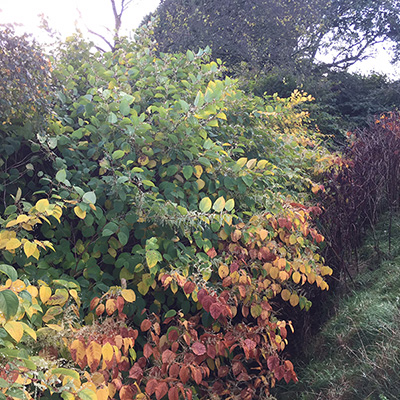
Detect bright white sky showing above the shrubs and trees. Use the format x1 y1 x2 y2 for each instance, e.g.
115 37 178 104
0 0 400 79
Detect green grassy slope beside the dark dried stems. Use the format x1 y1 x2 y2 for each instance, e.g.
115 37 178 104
276 212 400 400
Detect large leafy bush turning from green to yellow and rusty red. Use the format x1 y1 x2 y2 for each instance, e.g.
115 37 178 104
0 25 335 400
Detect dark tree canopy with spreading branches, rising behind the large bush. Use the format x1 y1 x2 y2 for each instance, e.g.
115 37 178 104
147 0 400 72
